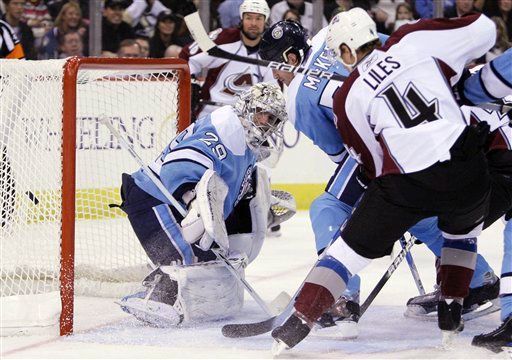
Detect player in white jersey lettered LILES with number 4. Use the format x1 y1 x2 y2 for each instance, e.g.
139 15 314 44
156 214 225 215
272 8 496 352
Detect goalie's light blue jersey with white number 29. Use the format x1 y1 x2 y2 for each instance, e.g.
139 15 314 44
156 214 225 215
132 106 256 217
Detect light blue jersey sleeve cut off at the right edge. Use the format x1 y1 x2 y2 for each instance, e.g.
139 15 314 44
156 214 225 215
464 49 512 105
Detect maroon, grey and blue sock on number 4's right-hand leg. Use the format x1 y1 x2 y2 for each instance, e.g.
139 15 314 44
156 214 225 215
440 238 477 298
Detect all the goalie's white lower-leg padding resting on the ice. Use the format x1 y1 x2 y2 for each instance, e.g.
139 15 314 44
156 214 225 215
118 256 247 327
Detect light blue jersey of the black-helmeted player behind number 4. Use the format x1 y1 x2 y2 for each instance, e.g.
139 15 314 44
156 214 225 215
287 27 388 163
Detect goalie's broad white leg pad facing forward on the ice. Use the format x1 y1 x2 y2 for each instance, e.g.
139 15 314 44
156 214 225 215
162 257 246 321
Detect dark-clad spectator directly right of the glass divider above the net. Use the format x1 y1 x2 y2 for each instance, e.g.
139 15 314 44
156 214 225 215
101 0 135 56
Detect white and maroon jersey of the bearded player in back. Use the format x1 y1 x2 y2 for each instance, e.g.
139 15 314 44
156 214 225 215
180 28 276 117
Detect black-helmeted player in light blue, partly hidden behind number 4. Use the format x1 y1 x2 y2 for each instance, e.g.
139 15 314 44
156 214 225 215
260 17 499 337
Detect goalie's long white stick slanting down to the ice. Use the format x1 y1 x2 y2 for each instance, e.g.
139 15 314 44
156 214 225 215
100 117 280 316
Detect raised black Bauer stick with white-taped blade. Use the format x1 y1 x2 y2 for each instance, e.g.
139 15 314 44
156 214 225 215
185 11 512 117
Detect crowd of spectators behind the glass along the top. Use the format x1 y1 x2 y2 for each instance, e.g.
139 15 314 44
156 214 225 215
0 0 512 62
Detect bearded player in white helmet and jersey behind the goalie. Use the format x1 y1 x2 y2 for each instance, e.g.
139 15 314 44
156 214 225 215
180 0 275 117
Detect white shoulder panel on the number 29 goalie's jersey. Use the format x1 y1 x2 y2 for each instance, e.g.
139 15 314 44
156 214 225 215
210 106 247 156
